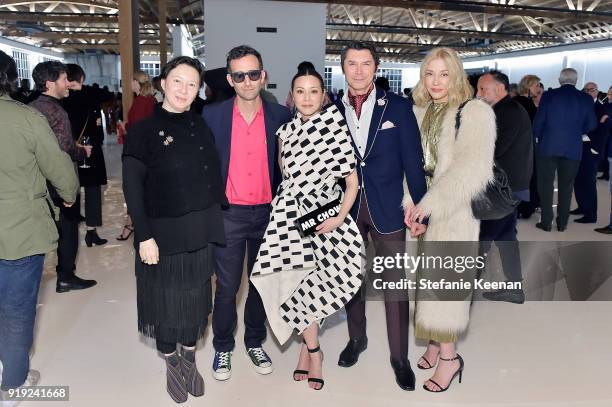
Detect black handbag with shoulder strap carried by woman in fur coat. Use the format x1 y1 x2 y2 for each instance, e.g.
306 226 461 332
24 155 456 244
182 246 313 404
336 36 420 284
455 100 521 220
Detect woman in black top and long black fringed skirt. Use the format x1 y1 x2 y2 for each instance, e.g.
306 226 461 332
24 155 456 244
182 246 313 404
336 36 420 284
123 57 227 403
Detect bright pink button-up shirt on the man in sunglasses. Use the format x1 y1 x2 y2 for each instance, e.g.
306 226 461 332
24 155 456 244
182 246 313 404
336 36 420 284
225 102 272 205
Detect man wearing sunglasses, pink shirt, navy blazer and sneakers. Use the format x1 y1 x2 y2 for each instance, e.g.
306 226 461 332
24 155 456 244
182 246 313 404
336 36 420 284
202 45 290 380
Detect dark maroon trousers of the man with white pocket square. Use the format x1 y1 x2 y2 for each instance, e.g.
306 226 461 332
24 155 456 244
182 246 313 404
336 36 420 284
345 194 409 361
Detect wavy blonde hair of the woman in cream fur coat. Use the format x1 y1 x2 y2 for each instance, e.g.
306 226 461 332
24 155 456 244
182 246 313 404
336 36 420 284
412 47 474 107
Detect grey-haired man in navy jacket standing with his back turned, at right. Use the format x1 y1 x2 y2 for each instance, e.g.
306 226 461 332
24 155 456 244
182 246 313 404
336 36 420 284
533 68 597 232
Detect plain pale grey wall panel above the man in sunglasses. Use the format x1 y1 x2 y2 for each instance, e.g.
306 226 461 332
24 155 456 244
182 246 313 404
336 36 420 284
204 0 327 103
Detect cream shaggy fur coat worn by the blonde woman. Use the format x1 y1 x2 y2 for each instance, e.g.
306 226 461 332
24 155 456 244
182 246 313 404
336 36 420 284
403 100 496 342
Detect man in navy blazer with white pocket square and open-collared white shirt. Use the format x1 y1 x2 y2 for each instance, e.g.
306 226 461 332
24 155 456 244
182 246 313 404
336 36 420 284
336 42 427 390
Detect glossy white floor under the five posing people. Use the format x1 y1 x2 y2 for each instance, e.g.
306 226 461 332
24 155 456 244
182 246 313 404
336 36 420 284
19 139 612 407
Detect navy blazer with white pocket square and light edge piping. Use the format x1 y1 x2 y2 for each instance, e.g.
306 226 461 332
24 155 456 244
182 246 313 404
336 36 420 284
336 87 427 233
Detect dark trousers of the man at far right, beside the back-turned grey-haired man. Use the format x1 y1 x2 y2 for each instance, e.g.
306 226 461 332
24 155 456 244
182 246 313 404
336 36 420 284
574 147 600 221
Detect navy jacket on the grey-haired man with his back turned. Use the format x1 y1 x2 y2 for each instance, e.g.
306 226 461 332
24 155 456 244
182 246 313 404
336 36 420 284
533 85 597 161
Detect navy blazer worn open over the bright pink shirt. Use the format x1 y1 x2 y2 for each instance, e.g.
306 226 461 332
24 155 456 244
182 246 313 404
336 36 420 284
202 96 291 196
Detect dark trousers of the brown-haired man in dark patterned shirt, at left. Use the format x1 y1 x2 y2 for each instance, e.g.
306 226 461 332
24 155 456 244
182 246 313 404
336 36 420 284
56 211 79 281
